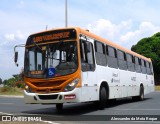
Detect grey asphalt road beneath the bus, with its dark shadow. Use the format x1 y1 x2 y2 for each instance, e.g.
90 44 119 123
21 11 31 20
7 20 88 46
0 92 160 124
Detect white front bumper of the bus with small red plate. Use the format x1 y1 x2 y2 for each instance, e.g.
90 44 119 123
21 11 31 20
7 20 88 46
24 88 81 104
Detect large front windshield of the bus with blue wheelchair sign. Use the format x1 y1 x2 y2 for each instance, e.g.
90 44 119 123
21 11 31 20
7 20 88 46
24 41 78 78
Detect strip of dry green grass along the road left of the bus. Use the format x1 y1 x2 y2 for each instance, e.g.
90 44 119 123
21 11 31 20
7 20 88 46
0 86 23 96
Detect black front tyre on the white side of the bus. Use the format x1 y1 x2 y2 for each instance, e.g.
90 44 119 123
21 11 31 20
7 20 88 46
98 87 107 109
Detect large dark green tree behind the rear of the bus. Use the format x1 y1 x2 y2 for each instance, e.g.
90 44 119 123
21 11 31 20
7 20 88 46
131 32 160 84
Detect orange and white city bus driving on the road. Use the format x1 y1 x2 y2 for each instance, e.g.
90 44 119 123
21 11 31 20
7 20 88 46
15 27 154 109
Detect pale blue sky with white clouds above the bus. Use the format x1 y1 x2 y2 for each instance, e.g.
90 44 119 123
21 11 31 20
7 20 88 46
0 0 160 80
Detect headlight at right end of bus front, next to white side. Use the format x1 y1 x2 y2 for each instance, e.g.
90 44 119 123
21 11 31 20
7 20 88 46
64 78 79 91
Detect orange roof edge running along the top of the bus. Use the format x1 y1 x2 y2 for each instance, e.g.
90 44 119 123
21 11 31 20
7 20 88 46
28 27 151 62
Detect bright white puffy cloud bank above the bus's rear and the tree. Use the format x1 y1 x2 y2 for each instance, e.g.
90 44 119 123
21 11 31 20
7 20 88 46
88 19 160 49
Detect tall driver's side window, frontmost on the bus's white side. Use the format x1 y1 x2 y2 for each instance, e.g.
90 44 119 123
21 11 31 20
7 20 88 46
80 40 95 71
